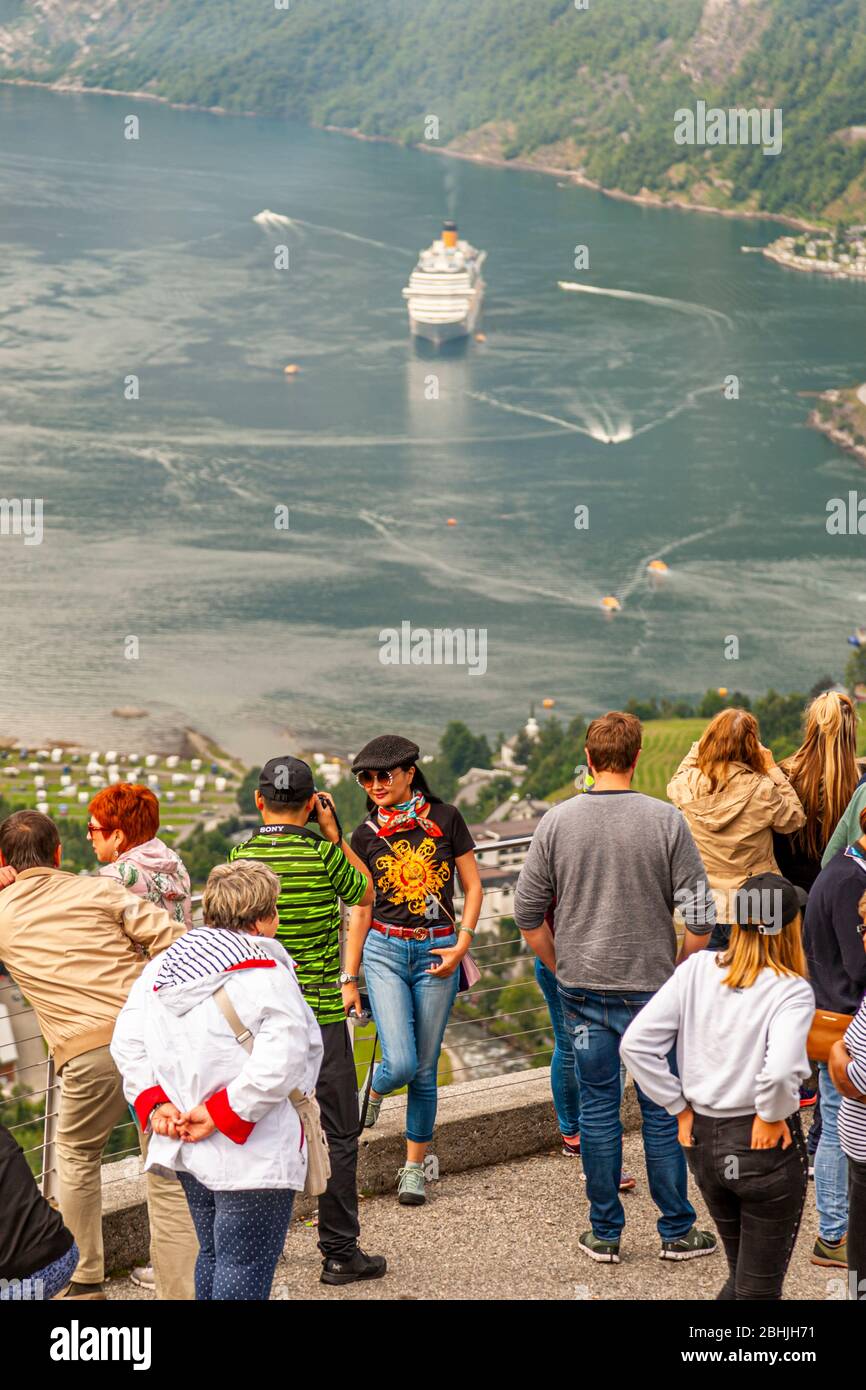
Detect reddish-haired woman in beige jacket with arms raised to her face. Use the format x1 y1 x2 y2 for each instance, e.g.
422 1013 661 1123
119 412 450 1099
667 709 806 949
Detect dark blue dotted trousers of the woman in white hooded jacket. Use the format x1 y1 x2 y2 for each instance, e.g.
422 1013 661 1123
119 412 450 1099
178 1173 295 1302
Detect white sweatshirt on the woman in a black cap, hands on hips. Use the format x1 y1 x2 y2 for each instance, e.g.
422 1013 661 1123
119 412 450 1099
620 951 815 1122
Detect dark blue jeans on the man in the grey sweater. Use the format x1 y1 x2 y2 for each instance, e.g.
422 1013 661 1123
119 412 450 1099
559 984 695 1241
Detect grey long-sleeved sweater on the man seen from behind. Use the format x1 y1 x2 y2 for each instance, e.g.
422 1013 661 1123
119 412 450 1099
514 791 716 992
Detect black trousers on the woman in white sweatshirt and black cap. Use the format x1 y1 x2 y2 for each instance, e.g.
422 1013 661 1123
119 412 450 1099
685 1113 809 1301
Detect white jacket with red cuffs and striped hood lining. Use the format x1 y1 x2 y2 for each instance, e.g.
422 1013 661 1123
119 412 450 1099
111 927 322 1191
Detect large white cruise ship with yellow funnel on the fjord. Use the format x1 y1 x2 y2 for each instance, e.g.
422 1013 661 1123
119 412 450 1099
403 222 487 343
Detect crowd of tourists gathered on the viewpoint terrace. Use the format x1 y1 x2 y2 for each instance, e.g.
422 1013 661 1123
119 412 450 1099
0 691 866 1300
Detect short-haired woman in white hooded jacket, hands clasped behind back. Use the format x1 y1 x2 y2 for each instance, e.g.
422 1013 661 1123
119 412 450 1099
111 859 322 1301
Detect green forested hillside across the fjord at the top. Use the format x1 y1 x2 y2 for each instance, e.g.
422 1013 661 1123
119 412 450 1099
0 0 866 222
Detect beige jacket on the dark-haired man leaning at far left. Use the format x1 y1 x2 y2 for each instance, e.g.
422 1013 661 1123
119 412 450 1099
0 869 183 1070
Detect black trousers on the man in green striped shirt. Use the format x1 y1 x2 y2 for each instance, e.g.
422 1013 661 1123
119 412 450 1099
316 1023 360 1259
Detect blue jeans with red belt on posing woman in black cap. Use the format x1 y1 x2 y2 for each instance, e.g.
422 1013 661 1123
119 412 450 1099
364 927 460 1144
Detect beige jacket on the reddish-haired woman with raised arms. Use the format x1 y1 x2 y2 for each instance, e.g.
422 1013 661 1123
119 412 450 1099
667 744 806 922
